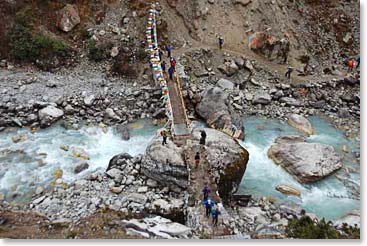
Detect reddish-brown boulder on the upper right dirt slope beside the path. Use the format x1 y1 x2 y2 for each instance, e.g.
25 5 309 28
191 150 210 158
249 32 290 63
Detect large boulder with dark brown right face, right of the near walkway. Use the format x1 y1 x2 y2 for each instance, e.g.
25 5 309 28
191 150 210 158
188 128 249 202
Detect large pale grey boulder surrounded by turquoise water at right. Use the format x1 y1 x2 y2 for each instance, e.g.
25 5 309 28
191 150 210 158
268 136 342 183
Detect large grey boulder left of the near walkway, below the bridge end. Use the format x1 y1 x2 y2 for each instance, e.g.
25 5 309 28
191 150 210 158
141 134 188 188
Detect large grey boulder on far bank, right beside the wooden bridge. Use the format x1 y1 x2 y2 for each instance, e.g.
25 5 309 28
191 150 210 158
195 87 244 139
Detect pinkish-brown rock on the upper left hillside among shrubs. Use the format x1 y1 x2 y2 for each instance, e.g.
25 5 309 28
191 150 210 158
57 4 80 32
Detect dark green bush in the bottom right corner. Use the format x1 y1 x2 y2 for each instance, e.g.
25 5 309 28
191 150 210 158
286 216 360 239
